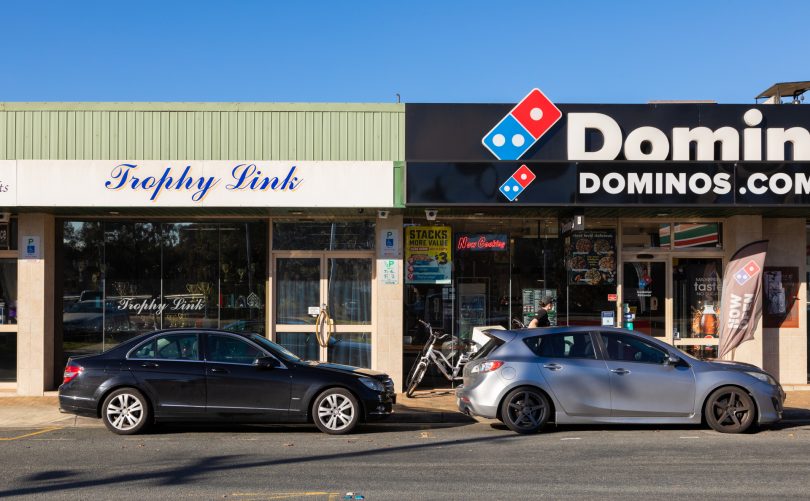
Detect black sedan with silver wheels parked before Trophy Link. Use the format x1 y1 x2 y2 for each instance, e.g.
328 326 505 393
59 329 396 435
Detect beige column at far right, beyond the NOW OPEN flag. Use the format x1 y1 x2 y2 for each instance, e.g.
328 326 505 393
762 218 807 384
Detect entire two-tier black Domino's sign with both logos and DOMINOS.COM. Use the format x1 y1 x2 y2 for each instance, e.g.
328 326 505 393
405 96 810 206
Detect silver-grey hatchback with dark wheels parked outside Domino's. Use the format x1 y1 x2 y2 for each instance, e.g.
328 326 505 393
456 327 785 433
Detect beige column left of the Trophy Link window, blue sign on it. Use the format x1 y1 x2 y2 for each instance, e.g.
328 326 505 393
17 214 56 395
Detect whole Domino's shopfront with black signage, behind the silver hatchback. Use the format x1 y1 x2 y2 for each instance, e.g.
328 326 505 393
404 98 810 385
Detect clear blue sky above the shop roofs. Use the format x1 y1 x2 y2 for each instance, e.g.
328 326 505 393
0 0 810 105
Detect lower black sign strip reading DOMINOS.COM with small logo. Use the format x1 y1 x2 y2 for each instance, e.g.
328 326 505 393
406 161 810 207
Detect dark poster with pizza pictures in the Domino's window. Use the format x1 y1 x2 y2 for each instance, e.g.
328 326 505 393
565 230 616 285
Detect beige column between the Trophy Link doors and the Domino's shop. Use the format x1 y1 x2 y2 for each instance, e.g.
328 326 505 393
378 216 405 392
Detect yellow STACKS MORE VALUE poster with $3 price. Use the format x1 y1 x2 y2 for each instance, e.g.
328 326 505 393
405 226 453 284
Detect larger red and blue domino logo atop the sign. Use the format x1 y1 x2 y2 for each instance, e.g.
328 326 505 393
481 89 562 160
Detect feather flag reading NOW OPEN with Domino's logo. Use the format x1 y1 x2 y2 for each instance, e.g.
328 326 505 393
717 240 768 358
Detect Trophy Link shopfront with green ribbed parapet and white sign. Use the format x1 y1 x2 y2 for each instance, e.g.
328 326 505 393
0 103 404 395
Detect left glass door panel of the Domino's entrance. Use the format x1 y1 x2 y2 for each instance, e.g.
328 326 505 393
620 260 668 337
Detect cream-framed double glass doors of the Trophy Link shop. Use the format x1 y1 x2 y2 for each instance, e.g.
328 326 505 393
273 252 374 367
